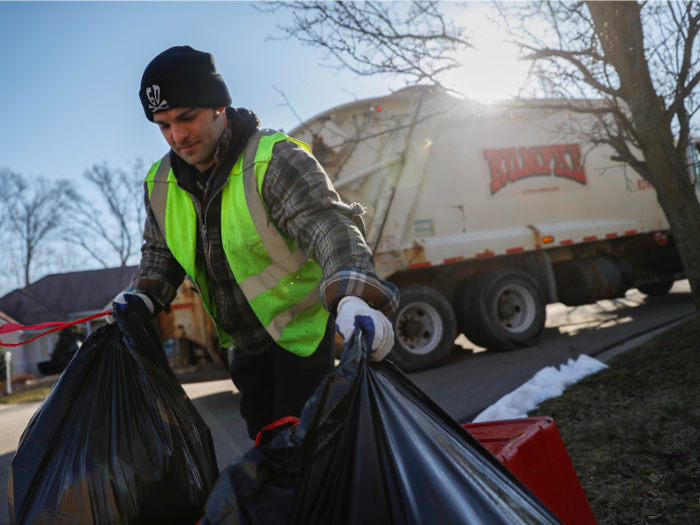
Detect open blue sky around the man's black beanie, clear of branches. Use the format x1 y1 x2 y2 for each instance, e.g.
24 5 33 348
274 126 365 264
0 0 514 184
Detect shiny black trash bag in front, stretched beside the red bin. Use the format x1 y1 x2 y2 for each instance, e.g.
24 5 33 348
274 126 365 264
202 334 560 525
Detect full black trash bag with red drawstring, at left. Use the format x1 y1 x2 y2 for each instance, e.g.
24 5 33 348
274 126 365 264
8 311 219 525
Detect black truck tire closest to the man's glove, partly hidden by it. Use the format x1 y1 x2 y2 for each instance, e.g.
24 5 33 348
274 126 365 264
388 284 457 372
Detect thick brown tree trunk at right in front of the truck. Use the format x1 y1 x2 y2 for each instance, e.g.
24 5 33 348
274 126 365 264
586 0 700 311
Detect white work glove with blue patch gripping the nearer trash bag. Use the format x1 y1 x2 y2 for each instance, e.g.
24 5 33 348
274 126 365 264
335 296 394 361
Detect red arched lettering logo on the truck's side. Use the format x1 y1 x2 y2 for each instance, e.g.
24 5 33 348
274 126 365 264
484 144 586 195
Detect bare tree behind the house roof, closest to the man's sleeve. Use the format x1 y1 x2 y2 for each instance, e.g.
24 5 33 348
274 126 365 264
63 159 145 268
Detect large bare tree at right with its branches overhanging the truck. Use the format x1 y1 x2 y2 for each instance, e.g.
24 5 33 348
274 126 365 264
262 0 700 309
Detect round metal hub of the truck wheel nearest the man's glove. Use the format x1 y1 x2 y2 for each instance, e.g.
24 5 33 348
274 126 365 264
396 303 442 355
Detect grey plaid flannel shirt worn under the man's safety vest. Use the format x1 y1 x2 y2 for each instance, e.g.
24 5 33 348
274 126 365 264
127 135 399 353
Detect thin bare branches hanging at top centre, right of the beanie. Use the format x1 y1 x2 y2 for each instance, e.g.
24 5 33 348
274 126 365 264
261 0 471 91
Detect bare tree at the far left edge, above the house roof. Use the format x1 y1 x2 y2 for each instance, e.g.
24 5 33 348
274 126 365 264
3 170 76 286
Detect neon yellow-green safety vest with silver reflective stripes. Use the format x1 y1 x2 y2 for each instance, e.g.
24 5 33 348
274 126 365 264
146 130 328 356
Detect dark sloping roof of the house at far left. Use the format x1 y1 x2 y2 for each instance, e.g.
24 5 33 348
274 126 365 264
0 266 138 325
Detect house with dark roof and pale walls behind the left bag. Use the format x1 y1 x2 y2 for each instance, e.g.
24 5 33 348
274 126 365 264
0 266 138 376
